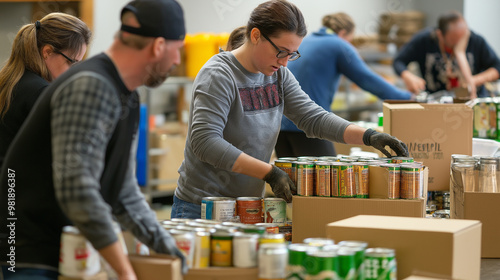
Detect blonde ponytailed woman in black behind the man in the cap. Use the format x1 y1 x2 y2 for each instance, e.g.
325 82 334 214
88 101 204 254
0 13 91 166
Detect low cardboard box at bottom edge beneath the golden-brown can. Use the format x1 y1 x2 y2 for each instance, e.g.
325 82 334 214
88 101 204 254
184 267 259 280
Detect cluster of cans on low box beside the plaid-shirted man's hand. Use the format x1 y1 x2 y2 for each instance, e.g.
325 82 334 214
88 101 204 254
161 219 292 268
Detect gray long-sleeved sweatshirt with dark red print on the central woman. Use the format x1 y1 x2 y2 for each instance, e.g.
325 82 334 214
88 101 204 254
175 52 350 204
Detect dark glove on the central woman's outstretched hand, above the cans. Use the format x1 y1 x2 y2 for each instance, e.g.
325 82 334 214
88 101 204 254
363 129 409 157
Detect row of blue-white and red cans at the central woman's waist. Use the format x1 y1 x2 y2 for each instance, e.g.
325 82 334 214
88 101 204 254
201 197 287 225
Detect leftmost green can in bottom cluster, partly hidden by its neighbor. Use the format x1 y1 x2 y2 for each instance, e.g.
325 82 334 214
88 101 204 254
286 243 319 280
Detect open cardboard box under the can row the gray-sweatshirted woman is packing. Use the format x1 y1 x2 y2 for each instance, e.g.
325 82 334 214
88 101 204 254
292 196 425 243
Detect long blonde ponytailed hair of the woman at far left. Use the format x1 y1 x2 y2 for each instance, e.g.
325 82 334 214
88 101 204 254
0 13 92 119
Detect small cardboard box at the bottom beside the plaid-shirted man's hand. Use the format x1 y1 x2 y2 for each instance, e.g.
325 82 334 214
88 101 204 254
128 254 182 280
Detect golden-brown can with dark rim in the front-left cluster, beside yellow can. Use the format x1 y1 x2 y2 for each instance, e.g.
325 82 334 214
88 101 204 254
210 231 233 267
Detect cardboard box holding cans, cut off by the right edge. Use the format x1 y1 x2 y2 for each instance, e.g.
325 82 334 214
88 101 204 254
450 192 500 258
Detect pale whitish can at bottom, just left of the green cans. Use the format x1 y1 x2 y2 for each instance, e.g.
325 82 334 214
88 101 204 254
259 243 288 279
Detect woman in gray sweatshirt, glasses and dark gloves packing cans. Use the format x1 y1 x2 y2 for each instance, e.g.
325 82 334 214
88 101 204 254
172 0 407 218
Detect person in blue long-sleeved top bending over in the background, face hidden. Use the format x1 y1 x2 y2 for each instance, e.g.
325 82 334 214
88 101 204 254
276 13 411 157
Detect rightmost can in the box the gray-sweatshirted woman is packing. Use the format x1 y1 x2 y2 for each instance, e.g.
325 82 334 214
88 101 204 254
399 164 424 199
